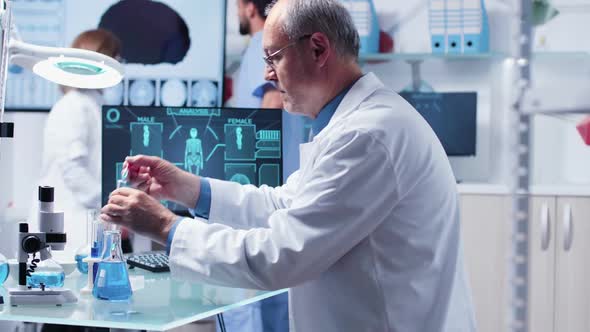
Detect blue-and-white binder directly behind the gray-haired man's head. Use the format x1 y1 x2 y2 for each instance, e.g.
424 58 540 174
340 0 379 54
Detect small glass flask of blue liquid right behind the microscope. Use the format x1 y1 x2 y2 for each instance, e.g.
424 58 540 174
27 247 66 288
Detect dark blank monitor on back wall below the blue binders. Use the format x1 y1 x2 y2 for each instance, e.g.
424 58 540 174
400 92 477 156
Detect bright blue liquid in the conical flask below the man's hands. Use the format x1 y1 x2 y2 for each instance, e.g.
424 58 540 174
92 261 132 301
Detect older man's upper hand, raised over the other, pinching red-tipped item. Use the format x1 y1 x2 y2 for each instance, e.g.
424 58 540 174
123 155 201 208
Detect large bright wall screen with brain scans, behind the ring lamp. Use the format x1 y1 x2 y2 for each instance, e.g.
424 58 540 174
6 0 226 109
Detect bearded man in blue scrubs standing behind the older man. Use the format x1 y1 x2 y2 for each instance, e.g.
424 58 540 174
224 0 292 332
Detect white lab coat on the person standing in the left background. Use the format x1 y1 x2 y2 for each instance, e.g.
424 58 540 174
29 90 103 253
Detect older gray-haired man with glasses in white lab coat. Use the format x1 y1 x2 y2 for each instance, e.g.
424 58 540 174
102 0 475 332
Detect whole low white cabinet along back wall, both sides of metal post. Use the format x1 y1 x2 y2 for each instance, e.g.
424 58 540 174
461 194 590 332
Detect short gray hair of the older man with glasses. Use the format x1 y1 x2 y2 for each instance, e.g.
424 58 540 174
266 0 360 59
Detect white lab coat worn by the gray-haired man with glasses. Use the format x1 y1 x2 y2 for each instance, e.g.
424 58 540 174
170 74 475 332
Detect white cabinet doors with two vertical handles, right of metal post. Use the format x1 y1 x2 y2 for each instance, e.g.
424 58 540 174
529 196 590 332
